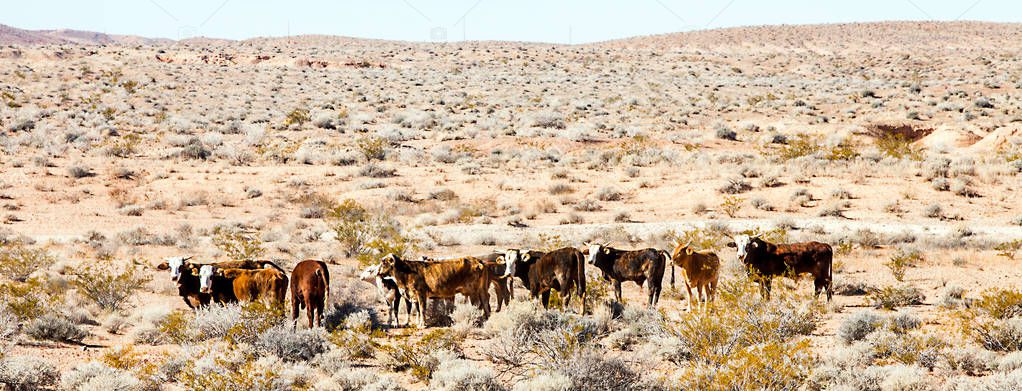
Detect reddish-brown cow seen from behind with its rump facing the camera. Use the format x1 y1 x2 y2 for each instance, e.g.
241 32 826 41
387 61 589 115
291 259 330 329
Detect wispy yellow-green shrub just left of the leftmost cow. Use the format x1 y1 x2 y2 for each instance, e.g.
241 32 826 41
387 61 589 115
73 265 150 310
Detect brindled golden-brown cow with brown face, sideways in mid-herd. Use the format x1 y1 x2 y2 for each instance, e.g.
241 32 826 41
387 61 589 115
379 254 491 328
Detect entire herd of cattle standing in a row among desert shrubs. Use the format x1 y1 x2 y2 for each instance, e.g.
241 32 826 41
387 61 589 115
157 235 833 328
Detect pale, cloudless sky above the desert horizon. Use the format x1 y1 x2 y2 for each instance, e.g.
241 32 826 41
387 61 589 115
0 0 1022 43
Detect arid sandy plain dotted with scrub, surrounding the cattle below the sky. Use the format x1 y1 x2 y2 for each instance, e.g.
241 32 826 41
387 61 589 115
0 22 1022 390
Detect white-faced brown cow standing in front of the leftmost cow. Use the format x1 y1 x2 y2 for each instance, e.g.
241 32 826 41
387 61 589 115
198 264 287 306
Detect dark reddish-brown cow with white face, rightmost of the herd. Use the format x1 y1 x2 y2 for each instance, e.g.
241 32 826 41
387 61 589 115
728 235 834 301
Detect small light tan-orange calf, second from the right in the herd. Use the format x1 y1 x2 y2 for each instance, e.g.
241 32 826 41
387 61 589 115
670 243 721 311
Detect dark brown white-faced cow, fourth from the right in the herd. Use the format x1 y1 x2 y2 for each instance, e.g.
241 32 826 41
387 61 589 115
504 247 587 313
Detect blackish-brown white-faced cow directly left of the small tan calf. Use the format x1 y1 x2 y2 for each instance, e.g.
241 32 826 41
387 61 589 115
586 244 667 307
